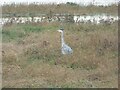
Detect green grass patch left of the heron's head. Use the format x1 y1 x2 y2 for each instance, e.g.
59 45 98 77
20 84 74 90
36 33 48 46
2 24 57 42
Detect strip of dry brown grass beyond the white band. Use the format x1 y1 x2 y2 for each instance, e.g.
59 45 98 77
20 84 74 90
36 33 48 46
2 4 118 16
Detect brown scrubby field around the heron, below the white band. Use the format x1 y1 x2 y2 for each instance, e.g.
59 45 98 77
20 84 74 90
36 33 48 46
2 22 118 88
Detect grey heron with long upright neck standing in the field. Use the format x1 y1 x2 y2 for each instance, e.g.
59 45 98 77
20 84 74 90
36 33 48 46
57 28 73 54
